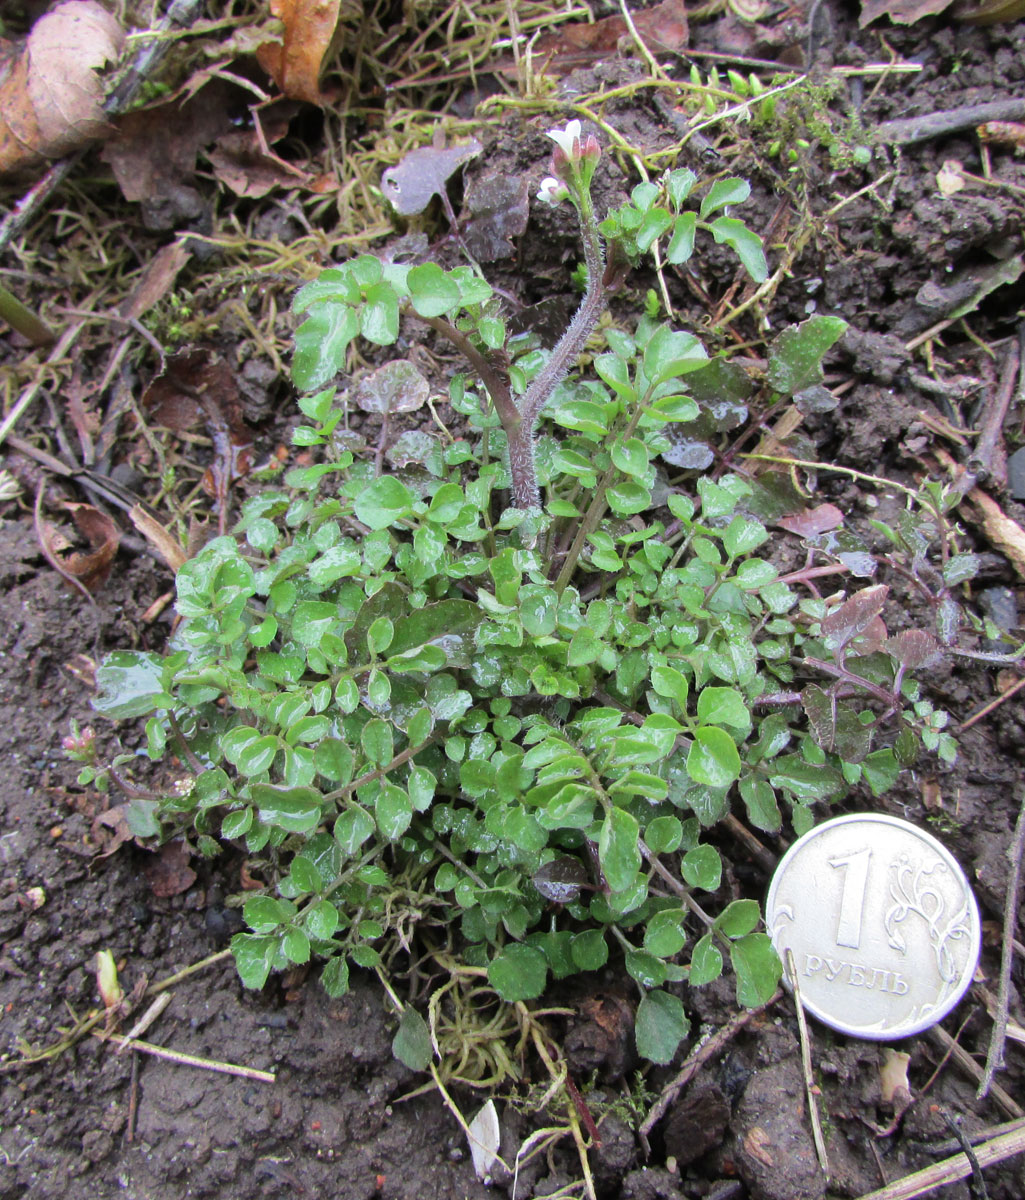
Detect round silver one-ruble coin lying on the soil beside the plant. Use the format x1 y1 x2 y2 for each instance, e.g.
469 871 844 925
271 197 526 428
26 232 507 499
766 812 982 1040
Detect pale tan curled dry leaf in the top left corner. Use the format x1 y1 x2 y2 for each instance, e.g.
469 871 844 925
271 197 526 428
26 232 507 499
0 0 125 174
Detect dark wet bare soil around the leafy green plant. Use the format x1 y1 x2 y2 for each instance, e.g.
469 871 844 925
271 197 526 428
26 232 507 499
0 5 1025 1200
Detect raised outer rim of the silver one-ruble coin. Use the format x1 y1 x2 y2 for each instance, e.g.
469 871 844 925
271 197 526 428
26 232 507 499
766 812 982 1042
